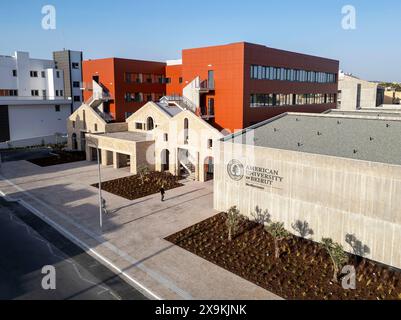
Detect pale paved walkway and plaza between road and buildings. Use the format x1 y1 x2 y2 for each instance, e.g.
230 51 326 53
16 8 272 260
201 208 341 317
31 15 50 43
0 161 279 299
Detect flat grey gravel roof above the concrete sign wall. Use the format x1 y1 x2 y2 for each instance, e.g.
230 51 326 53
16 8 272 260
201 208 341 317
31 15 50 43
223 113 401 165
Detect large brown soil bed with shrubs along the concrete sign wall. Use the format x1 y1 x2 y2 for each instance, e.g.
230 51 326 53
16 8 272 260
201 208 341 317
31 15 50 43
166 213 401 300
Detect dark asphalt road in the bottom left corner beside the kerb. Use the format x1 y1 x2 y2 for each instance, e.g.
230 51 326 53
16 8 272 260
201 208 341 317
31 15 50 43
0 197 146 300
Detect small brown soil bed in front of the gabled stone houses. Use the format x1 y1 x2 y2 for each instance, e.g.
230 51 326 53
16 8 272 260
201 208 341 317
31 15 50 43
92 171 183 200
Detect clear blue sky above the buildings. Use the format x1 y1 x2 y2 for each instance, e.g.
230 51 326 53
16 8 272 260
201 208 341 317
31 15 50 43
0 0 401 82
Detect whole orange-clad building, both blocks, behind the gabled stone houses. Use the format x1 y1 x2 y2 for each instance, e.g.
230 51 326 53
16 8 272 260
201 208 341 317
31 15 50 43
83 42 339 132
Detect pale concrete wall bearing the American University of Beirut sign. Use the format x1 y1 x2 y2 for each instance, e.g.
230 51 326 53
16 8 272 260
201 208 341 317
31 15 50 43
214 142 401 268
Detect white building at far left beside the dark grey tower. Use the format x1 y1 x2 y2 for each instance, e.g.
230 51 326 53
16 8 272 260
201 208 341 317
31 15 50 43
0 52 72 146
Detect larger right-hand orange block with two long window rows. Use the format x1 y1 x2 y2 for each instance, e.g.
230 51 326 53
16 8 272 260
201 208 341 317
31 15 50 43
166 42 339 132
